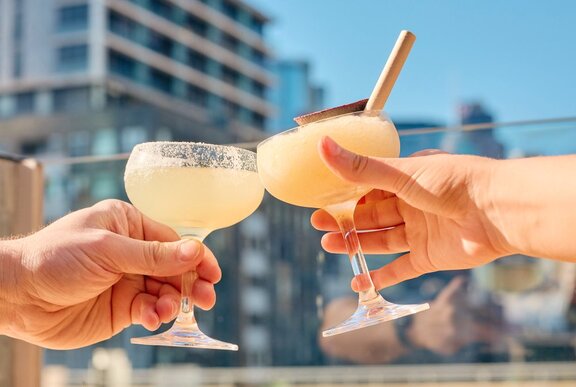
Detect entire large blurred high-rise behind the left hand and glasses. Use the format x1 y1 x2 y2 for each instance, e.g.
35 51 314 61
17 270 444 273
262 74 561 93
0 0 332 368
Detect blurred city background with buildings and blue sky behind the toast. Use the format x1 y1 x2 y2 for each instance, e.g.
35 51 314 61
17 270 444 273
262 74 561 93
0 0 576 387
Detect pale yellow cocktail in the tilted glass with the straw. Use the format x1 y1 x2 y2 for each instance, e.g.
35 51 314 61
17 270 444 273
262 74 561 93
258 115 400 208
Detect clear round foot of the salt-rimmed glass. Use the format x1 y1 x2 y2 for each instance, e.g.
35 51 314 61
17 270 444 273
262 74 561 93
130 322 238 351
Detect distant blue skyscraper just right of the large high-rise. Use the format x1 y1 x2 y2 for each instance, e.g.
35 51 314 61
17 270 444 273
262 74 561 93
269 60 325 133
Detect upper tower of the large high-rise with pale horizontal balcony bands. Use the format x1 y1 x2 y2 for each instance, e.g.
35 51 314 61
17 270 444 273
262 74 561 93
0 0 272 135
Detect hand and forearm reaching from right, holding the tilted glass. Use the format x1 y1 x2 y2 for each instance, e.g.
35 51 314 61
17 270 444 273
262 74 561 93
312 138 576 288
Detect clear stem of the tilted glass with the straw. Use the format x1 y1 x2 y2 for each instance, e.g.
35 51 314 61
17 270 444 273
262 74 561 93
325 201 380 304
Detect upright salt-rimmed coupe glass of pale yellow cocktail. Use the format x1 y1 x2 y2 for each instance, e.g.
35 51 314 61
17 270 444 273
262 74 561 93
124 142 264 351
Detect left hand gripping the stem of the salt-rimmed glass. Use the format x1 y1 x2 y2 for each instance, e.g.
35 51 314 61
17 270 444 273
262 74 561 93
0 200 221 349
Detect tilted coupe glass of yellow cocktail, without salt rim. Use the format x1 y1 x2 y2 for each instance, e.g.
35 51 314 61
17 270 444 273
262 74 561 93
257 111 429 336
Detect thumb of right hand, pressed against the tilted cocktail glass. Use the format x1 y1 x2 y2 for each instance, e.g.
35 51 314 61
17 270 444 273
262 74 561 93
319 136 418 194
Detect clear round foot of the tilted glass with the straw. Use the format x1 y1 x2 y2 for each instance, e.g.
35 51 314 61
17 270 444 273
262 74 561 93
322 296 430 337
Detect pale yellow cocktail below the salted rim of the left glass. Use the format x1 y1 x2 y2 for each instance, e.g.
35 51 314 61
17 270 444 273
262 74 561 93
124 167 264 234
